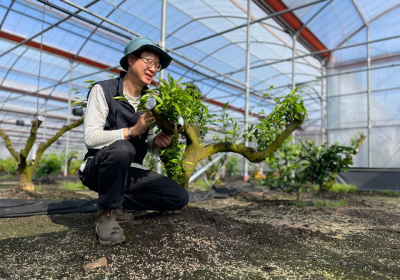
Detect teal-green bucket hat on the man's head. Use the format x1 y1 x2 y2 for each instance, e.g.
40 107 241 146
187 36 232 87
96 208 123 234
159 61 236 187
119 37 172 70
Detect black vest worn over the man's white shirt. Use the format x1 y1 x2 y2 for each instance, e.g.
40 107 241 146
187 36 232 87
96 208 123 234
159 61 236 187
84 71 149 164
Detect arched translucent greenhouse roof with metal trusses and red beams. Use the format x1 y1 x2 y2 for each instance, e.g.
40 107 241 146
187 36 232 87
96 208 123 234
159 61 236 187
0 0 400 152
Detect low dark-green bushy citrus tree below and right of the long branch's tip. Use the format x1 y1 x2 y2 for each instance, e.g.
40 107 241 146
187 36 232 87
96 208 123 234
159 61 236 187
265 133 365 202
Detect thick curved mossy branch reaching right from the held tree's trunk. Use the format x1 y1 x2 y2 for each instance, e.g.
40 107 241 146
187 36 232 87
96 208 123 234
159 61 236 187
199 120 302 163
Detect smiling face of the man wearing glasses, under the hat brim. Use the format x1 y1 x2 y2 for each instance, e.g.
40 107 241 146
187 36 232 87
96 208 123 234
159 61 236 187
128 51 160 86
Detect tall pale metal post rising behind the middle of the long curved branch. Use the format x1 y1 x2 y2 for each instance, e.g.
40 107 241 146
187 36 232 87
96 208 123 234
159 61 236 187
243 0 251 182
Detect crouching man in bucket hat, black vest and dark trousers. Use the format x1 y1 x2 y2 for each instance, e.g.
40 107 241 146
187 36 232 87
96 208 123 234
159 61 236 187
79 37 189 245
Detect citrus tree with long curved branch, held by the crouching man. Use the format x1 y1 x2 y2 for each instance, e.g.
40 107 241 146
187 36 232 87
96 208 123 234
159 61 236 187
139 76 307 189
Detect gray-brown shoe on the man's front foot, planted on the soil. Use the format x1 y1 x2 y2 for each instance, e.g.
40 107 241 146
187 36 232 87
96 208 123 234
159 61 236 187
96 209 125 245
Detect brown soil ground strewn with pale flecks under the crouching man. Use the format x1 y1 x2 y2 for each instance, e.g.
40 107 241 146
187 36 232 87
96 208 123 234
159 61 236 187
0 180 400 280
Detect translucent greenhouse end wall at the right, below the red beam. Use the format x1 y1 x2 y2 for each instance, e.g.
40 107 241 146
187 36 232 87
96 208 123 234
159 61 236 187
327 56 400 168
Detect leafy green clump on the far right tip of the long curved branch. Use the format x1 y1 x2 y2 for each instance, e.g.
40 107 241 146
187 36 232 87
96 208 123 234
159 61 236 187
245 89 307 151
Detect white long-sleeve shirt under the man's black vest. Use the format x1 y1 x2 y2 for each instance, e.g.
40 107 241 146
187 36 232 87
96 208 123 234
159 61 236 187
79 84 160 171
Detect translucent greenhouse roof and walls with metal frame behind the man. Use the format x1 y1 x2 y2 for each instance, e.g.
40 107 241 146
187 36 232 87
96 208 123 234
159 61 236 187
0 0 400 167
